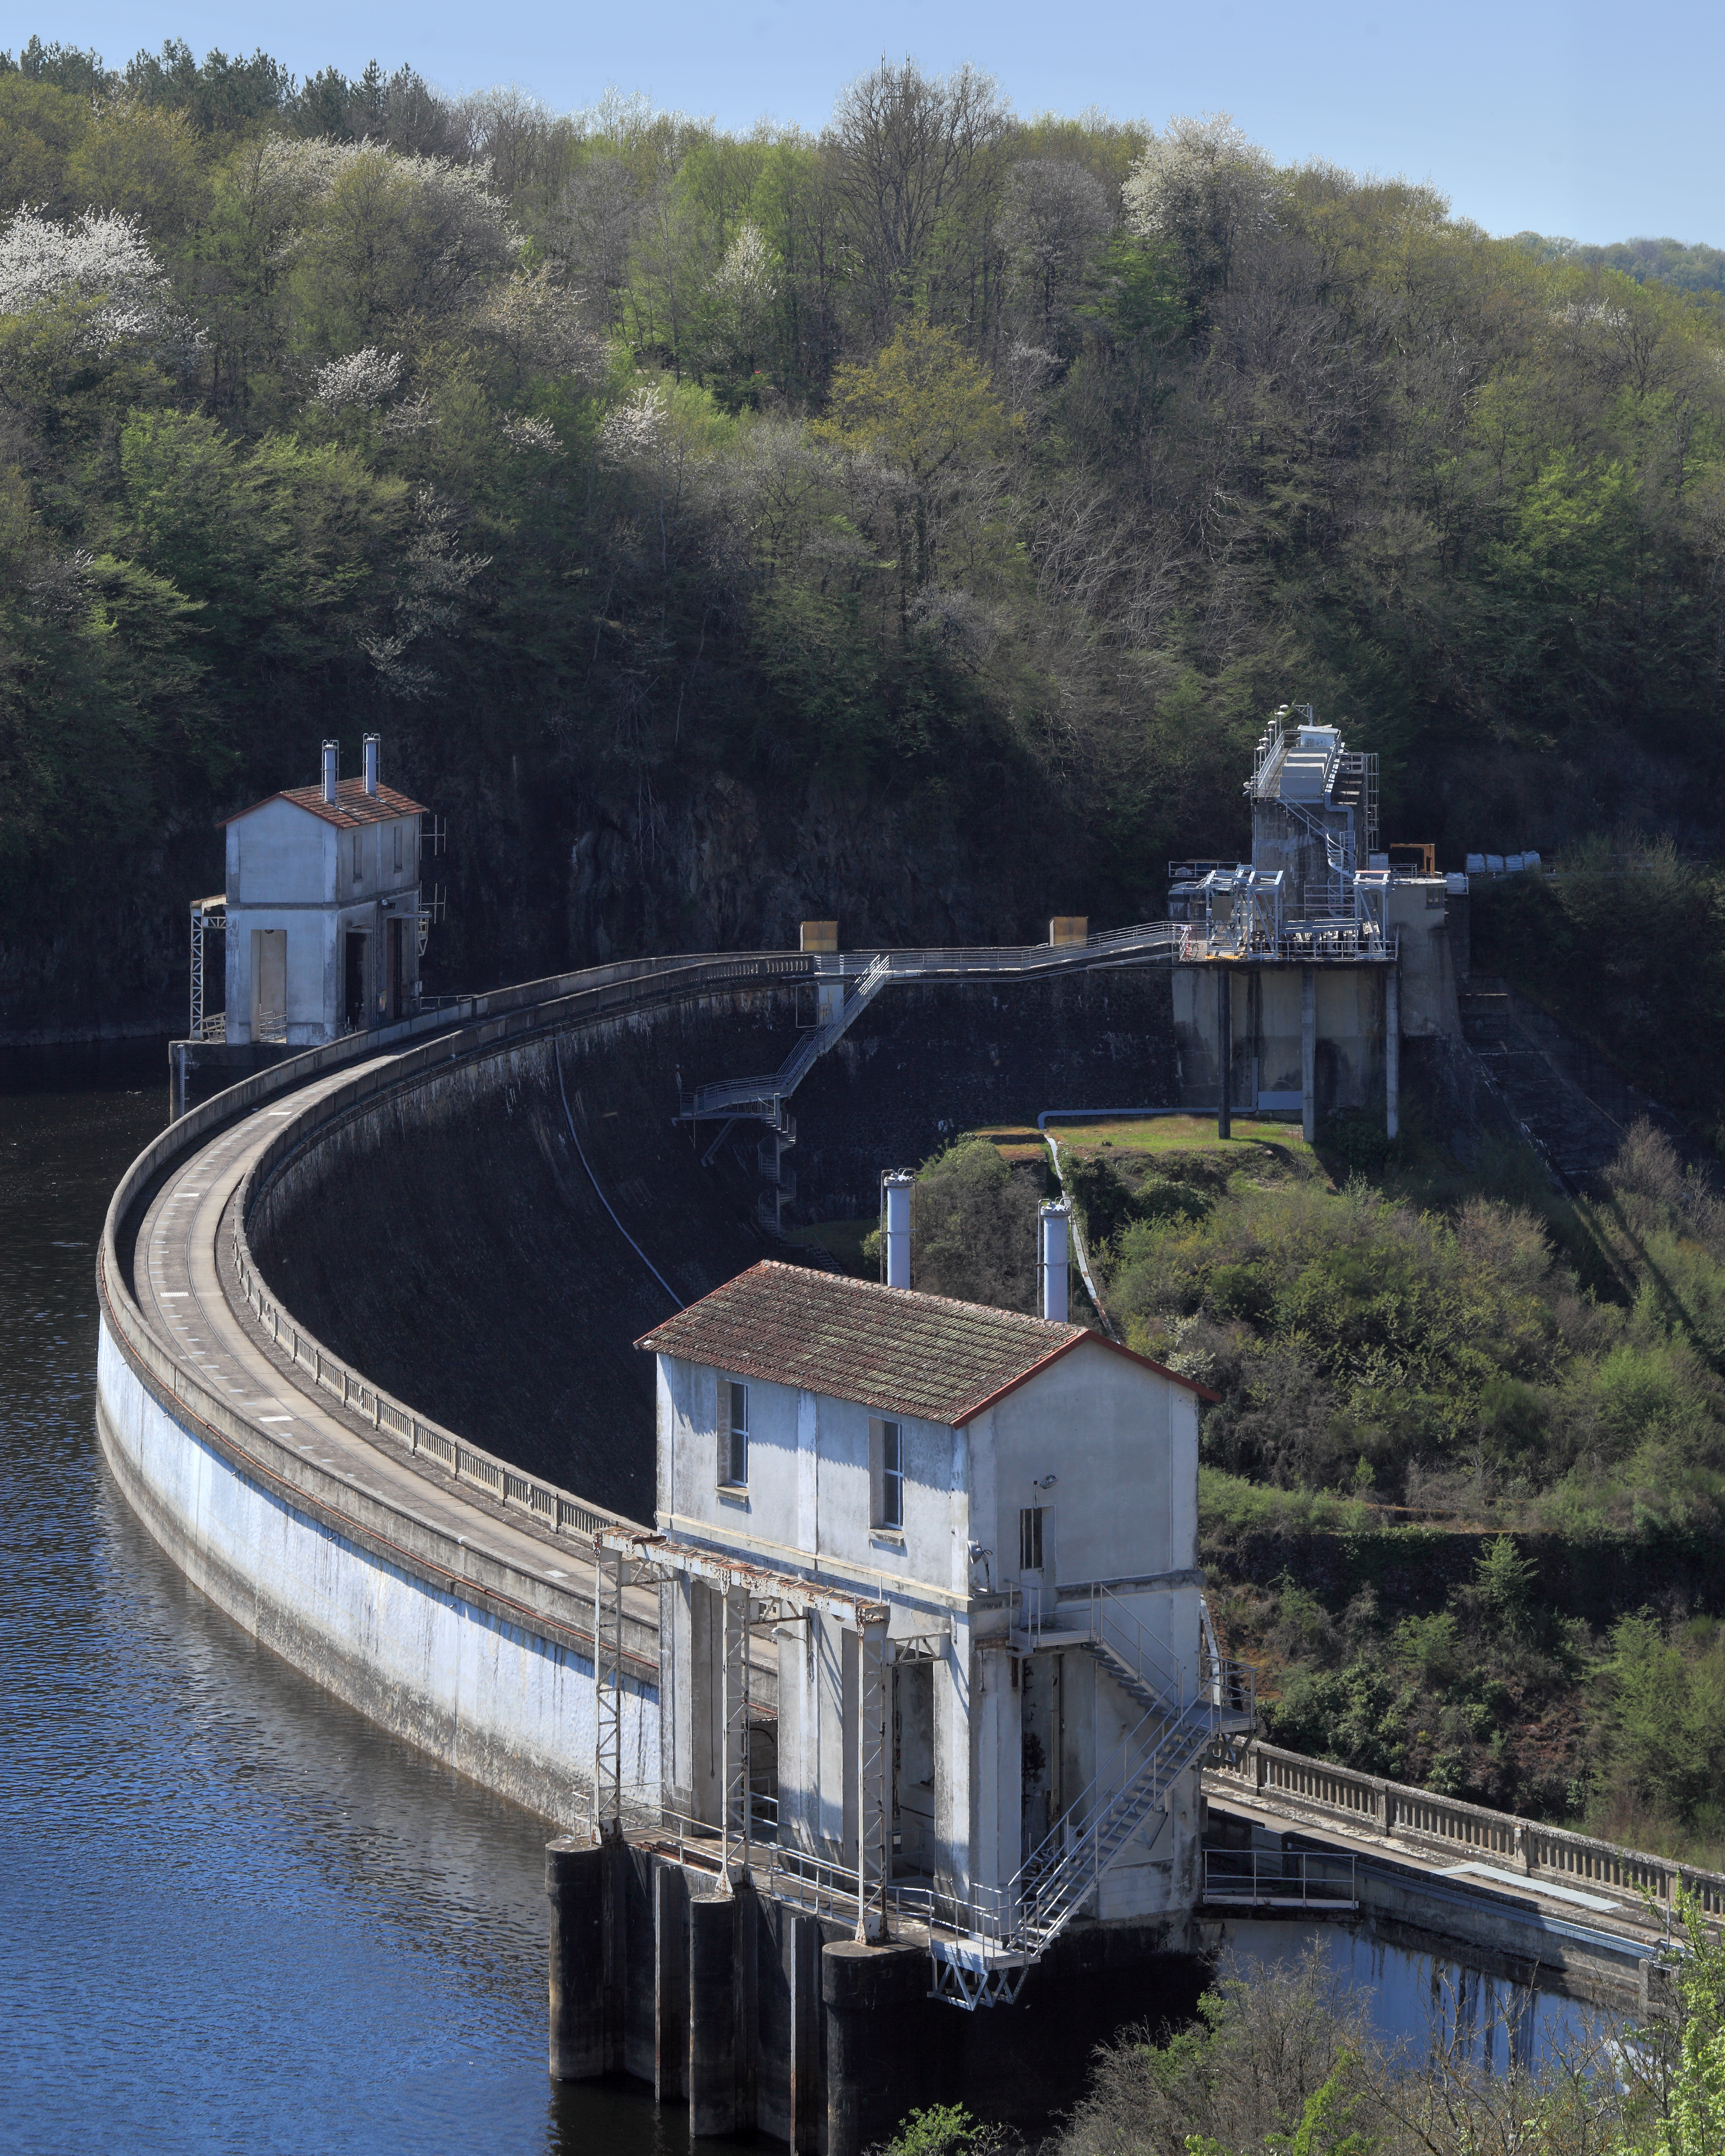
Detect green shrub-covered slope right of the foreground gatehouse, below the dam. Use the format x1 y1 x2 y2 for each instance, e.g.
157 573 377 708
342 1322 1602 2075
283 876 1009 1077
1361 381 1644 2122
888 1115 1725 1865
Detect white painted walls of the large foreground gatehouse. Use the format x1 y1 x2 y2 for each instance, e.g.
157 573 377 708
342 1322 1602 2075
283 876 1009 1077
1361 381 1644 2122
658 1339 1201 1917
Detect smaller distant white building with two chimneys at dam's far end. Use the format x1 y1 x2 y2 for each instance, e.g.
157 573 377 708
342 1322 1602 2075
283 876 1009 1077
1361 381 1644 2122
224 735 425 1048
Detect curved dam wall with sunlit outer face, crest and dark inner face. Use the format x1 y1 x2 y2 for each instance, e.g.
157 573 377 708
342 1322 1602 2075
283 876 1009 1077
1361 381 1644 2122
99 955 1177 1826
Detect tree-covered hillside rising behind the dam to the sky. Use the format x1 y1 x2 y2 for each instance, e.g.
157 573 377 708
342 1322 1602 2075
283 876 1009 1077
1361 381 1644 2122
0 43 1725 1035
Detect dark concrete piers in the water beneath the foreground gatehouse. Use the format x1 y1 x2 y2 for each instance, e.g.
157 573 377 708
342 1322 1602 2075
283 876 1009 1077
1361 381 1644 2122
545 1837 1205 2156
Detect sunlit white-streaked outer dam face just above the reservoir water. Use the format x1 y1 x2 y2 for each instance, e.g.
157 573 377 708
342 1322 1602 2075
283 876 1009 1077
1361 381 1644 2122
97 1313 660 1828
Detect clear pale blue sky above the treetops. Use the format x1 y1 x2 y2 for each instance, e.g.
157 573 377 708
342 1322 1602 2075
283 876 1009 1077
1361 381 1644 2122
30 0 1725 246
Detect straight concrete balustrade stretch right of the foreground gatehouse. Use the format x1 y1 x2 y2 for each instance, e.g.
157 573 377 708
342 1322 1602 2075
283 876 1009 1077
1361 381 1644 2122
1203 1740 1725 1917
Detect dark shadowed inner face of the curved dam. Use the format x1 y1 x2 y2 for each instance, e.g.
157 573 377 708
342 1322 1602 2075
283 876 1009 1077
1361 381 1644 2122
250 968 1177 1520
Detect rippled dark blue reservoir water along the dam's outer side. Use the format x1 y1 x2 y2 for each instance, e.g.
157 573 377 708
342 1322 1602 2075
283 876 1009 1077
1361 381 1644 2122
0 1041 1621 2156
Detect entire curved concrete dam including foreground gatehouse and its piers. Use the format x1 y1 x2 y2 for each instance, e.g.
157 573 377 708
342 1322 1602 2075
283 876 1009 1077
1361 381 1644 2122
99 923 1725 2156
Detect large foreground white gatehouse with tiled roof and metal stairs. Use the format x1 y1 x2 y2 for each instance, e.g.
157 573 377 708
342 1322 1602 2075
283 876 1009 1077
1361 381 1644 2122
636 1263 1238 1981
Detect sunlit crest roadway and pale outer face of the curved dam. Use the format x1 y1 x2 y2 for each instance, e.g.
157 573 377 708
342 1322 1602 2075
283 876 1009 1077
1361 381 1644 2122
97 962 776 1826
